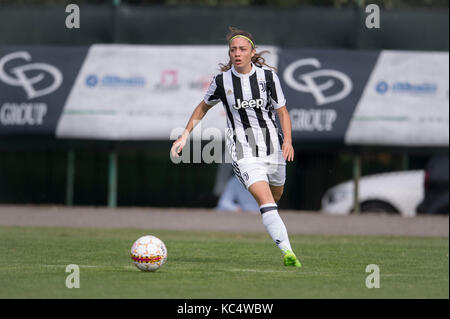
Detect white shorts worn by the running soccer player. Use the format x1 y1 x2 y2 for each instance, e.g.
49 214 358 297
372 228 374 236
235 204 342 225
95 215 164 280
232 157 286 189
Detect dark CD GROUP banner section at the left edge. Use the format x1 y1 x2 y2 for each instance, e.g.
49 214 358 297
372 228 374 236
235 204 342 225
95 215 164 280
0 45 89 138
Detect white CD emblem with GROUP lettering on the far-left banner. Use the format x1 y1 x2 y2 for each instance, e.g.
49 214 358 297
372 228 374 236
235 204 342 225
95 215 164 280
0 51 63 125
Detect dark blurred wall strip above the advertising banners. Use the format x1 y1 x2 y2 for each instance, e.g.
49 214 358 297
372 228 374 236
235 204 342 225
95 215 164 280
0 0 448 50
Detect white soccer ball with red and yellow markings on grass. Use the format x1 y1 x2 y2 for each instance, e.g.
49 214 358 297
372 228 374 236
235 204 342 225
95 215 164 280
131 235 167 271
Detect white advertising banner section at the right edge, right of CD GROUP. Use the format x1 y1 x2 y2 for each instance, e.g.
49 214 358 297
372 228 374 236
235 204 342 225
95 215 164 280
345 51 449 147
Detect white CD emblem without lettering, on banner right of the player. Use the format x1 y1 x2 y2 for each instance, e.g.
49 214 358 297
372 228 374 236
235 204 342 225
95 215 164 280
283 58 353 105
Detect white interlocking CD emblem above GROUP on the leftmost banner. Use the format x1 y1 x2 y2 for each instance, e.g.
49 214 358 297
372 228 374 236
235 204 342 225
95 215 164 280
0 51 63 100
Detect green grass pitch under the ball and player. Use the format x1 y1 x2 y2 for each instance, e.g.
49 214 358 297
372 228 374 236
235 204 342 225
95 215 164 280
0 226 449 299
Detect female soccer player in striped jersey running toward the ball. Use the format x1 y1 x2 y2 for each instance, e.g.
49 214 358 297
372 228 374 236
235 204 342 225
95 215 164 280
171 28 301 267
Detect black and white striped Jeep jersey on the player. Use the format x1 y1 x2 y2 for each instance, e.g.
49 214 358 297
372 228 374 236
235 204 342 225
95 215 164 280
204 64 286 163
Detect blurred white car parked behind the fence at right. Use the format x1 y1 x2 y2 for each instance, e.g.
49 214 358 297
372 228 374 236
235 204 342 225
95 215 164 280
321 170 425 217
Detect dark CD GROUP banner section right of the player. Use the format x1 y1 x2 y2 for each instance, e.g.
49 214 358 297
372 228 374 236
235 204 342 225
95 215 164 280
278 49 379 143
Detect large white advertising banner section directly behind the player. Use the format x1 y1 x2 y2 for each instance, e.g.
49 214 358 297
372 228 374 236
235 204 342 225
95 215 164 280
56 45 277 140
